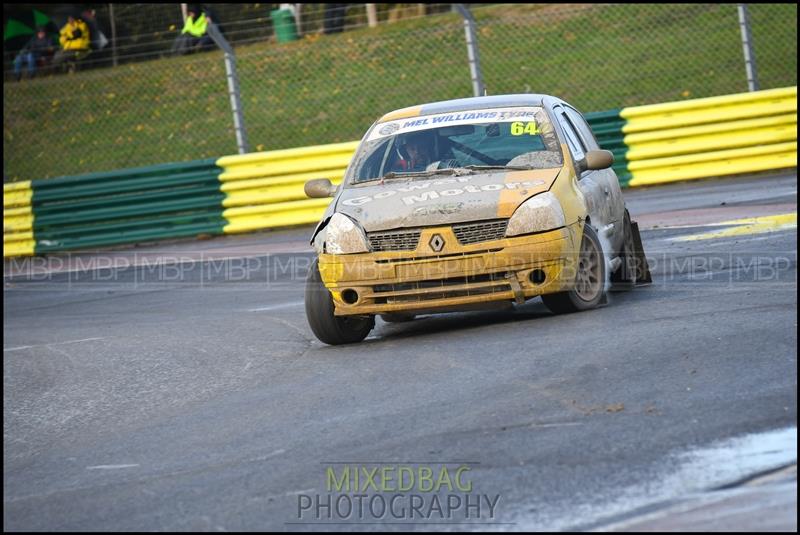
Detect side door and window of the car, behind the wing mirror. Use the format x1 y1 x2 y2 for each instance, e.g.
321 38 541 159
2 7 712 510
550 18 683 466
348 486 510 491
554 105 625 250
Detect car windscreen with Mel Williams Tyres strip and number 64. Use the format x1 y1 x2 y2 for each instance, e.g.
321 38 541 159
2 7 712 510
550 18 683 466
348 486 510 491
346 107 563 183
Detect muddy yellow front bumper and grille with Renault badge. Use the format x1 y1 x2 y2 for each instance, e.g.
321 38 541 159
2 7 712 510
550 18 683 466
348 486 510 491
319 223 581 316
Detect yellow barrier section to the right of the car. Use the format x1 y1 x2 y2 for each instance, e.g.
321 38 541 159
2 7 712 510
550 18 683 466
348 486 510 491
620 87 797 186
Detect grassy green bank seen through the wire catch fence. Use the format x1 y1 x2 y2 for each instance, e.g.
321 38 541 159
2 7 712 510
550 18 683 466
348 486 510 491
3 4 797 182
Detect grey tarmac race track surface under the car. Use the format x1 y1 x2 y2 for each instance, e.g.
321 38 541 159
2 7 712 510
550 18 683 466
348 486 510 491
3 173 797 531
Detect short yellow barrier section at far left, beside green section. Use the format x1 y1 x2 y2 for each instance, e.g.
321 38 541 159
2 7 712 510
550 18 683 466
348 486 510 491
3 181 36 257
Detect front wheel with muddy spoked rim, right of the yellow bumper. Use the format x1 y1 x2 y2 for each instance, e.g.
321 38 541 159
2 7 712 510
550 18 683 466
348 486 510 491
542 224 606 314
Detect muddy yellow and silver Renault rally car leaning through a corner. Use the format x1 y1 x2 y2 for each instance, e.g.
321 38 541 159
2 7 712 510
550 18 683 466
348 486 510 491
305 94 649 344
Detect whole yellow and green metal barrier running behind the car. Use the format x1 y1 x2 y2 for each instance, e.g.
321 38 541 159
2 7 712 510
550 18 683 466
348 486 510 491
3 87 797 256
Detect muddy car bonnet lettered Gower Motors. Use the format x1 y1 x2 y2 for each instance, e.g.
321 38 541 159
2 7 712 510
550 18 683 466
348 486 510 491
336 167 561 232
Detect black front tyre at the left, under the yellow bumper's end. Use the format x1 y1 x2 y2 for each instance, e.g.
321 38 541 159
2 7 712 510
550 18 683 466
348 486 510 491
306 259 375 346
